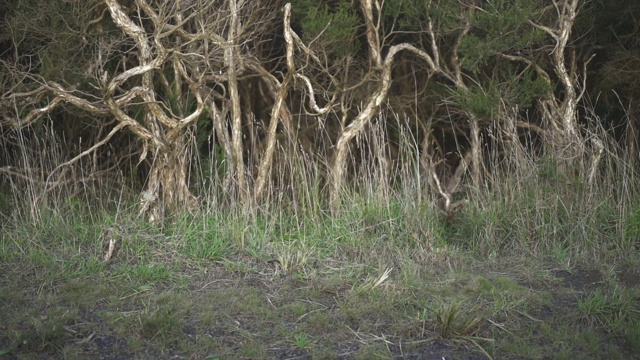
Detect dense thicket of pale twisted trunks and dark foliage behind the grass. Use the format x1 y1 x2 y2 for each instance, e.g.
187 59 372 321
0 0 640 226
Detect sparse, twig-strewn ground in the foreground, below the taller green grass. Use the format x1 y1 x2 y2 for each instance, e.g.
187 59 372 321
0 252 640 360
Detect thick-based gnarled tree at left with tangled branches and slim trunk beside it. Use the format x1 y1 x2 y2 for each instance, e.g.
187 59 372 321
0 0 274 221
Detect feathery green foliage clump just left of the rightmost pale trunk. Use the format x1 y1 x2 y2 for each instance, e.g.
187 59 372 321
442 0 553 118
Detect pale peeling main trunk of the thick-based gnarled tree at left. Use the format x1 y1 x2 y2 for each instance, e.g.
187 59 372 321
104 0 204 222
